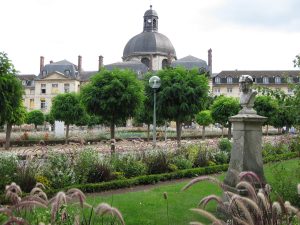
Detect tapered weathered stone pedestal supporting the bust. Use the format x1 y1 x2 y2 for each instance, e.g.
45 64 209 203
224 112 267 188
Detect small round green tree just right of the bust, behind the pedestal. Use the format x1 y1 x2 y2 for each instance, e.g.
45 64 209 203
254 95 278 134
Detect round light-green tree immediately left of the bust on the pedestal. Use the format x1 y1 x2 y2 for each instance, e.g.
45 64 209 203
210 95 241 138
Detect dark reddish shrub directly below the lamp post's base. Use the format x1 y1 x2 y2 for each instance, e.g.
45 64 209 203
144 150 171 174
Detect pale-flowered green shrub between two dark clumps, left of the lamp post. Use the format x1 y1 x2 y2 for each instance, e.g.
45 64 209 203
112 154 147 178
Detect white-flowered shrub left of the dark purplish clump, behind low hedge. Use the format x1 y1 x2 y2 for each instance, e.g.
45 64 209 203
39 152 76 188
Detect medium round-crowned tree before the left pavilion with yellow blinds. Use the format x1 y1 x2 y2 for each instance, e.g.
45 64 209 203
50 93 84 144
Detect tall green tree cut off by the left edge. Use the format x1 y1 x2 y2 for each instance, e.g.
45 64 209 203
0 52 23 149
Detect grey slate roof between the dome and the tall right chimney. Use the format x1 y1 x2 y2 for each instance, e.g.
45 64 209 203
171 55 208 71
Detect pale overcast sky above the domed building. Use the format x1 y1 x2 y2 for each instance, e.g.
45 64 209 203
0 0 300 74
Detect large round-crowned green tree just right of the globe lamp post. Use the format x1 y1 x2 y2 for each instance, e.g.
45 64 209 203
157 67 209 146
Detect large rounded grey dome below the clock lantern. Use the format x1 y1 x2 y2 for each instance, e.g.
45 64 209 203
123 32 176 58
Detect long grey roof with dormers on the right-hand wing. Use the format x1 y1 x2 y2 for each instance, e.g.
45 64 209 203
215 70 300 77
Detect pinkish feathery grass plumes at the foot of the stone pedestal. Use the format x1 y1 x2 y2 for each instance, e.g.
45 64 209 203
182 172 300 225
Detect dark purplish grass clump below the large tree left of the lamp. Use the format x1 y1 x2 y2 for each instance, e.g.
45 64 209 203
87 161 115 183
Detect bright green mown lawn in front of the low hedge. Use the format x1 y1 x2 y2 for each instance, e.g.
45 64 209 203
87 159 299 225
